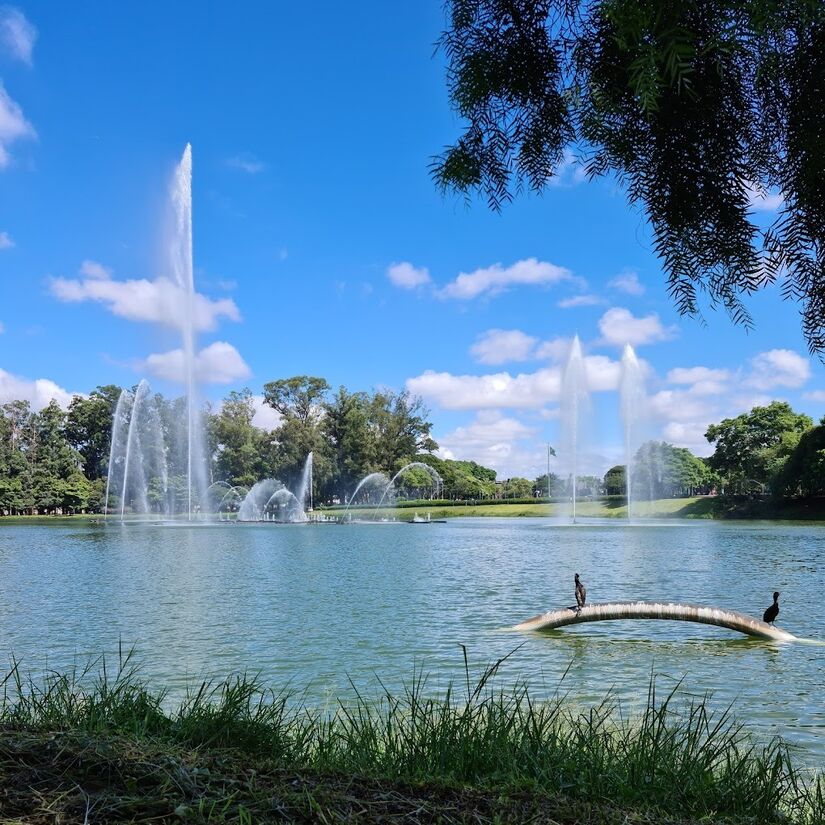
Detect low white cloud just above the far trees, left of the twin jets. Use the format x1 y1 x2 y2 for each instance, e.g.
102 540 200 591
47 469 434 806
437 410 541 478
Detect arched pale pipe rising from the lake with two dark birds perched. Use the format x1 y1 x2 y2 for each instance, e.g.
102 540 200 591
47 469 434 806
513 602 796 642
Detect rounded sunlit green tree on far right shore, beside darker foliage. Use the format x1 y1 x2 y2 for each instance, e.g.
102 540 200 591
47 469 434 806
705 401 813 491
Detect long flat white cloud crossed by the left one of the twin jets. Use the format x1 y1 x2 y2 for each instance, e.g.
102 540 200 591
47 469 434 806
406 355 621 410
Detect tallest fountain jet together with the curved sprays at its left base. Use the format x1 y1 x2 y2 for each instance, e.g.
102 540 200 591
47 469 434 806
106 144 208 520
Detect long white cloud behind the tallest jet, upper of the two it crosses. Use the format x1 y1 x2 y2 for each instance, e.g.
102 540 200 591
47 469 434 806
51 261 240 331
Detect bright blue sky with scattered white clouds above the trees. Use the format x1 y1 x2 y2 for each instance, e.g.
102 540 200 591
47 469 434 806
0 2 825 476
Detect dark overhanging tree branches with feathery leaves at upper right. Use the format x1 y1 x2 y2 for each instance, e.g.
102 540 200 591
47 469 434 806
432 0 825 355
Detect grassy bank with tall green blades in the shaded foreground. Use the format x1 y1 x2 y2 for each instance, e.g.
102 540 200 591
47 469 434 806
0 662 825 825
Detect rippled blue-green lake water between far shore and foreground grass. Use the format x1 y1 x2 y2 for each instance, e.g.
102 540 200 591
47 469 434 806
0 518 825 764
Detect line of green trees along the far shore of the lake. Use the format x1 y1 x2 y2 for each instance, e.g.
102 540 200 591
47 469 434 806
0 375 825 515
